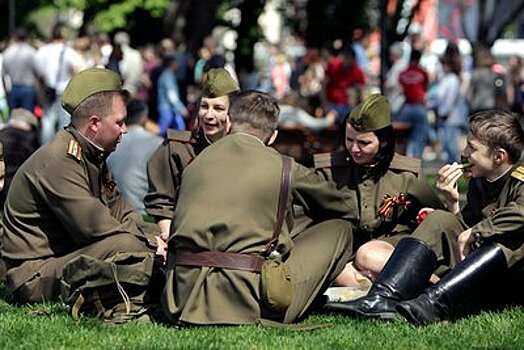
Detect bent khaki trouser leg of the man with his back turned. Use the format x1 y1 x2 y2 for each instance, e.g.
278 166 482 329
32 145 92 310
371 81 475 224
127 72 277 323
284 219 353 323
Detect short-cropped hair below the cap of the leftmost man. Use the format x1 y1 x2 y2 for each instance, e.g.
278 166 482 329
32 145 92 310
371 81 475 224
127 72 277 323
71 91 125 127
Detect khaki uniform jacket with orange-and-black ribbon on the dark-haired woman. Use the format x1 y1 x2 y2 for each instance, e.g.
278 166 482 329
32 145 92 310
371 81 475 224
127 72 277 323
315 152 443 247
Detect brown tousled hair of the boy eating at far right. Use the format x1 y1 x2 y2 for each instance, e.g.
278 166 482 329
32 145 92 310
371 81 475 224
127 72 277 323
469 110 524 164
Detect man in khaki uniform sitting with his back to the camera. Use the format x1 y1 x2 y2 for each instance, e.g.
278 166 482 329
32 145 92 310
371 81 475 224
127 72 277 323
162 91 356 325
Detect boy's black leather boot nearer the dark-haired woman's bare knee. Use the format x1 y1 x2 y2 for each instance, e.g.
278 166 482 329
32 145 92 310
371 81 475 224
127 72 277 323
324 238 437 320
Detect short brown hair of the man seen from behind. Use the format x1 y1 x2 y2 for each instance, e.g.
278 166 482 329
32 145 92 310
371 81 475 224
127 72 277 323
229 90 280 141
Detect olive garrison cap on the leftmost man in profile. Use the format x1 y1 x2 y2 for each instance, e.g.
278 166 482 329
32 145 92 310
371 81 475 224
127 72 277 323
62 68 122 114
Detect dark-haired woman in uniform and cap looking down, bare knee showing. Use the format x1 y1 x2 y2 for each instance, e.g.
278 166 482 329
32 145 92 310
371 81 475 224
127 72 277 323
315 94 445 286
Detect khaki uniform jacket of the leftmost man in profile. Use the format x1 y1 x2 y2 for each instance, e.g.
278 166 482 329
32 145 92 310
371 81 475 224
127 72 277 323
2 127 156 289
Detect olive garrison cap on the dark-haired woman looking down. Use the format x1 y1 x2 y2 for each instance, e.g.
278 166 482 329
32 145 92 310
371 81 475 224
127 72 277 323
348 94 391 132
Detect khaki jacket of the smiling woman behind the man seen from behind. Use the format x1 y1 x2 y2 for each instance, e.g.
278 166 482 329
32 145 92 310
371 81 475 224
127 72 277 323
144 129 209 220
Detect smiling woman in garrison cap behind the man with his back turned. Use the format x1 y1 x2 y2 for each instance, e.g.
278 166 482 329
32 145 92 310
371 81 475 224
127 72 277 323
144 68 240 239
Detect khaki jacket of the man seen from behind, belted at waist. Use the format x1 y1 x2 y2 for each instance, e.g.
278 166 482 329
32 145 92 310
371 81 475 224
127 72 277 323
163 133 356 324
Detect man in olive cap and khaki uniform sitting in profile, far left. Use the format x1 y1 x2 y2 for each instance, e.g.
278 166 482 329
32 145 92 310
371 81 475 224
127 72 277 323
2 68 161 303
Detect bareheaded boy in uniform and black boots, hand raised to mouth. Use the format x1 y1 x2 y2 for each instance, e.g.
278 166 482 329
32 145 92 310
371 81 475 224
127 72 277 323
328 110 524 325
